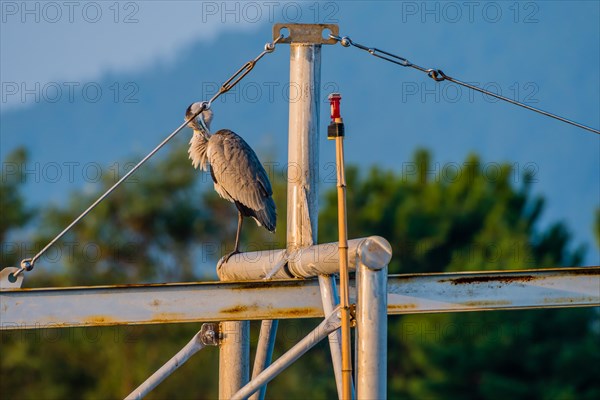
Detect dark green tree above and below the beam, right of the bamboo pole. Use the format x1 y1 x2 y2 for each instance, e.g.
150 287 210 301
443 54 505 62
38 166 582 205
320 150 600 399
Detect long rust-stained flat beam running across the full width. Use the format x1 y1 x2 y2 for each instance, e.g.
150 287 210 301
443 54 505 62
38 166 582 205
0 267 600 330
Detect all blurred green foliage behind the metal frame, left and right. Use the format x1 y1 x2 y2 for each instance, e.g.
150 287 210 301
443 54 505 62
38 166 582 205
0 141 600 399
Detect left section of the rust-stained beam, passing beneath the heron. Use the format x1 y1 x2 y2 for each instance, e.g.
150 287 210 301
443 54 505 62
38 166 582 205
0 280 323 329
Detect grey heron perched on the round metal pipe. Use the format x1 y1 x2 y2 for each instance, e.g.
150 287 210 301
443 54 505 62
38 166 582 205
185 103 277 262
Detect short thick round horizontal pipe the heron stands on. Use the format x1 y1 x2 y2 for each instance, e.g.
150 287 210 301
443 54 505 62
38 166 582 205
217 236 392 281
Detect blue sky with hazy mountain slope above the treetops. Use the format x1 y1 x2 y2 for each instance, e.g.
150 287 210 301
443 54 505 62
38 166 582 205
0 1 600 264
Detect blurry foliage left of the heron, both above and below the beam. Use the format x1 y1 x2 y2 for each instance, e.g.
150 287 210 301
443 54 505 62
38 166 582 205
0 142 223 399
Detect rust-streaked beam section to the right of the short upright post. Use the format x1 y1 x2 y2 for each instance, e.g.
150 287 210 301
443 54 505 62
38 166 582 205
388 267 600 314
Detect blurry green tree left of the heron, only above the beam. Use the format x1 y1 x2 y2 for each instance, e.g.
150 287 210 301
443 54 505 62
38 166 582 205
28 141 230 285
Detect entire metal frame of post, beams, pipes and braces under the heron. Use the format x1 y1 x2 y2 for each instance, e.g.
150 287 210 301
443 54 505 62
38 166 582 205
0 24 600 399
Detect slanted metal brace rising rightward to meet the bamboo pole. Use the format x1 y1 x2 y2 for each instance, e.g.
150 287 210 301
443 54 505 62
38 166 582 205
231 310 340 400
